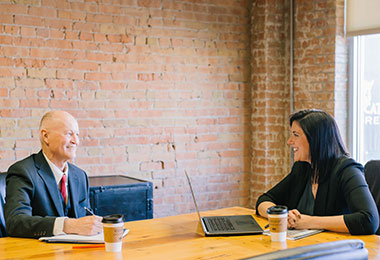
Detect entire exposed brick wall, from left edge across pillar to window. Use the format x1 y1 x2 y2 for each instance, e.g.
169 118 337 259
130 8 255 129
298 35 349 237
0 0 346 217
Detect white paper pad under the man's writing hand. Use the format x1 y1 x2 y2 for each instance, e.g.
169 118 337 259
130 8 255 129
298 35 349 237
39 229 129 244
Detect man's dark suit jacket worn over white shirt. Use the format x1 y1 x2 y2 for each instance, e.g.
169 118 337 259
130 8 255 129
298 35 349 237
4 151 89 238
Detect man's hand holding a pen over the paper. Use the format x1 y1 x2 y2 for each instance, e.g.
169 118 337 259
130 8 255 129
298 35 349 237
63 216 103 236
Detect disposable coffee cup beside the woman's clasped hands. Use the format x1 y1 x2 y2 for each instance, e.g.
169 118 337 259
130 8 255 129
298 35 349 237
267 205 288 242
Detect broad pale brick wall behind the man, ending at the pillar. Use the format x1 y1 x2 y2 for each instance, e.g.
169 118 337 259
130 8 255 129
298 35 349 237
0 0 251 217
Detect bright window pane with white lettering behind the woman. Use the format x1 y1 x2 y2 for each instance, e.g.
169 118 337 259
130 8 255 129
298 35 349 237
349 34 380 165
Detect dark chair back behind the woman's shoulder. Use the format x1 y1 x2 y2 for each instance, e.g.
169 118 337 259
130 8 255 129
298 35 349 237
364 160 380 235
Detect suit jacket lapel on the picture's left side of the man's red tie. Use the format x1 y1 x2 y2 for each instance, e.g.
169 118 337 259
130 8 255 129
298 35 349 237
35 150 65 216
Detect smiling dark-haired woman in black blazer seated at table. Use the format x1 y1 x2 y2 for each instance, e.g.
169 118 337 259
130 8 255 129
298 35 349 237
256 110 379 235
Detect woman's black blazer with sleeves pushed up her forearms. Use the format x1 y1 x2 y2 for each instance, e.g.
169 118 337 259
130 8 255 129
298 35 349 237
256 156 379 235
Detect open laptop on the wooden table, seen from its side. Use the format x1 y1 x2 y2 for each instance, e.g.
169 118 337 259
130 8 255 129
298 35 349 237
185 171 263 236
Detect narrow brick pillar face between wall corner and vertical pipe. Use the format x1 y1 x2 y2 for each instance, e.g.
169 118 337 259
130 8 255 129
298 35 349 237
250 1 290 206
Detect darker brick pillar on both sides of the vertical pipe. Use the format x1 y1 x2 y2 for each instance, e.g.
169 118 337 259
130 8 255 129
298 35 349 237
250 0 347 206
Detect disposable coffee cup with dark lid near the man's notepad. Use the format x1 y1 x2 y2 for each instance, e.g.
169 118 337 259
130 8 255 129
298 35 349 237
102 214 124 252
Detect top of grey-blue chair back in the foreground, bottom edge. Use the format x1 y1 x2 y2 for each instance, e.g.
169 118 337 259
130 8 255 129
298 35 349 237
245 239 368 260
